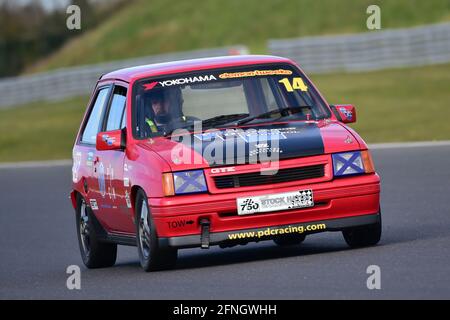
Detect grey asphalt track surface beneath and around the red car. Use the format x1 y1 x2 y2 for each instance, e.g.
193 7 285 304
0 146 450 299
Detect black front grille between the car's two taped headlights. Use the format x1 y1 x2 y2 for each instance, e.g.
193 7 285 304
213 164 325 189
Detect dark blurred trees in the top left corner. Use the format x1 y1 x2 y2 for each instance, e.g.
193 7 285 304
0 0 125 77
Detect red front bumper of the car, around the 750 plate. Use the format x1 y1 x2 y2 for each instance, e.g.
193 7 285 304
149 174 380 246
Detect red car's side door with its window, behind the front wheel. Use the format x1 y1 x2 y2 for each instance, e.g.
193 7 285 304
94 83 134 233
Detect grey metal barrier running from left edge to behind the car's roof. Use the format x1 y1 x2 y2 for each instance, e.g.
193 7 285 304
0 46 248 108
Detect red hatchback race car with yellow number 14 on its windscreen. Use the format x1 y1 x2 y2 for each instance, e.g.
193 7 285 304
71 56 381 271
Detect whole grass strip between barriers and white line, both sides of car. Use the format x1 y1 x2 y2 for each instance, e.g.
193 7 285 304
0 64 450 162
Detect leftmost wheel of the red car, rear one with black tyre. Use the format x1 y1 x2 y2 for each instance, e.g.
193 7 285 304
76 196 117 269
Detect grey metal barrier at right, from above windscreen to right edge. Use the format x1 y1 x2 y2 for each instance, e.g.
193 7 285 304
269 23 450 73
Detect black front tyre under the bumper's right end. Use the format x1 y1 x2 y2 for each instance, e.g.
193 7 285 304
342 213 382 248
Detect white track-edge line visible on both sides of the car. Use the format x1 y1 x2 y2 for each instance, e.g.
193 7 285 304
0 140 450 169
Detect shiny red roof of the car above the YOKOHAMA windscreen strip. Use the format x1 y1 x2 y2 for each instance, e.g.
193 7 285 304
100 55 293 82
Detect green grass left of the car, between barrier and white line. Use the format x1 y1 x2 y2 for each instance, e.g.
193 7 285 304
0 97 88 162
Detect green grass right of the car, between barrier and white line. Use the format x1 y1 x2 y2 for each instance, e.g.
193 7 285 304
312 64 450 142
